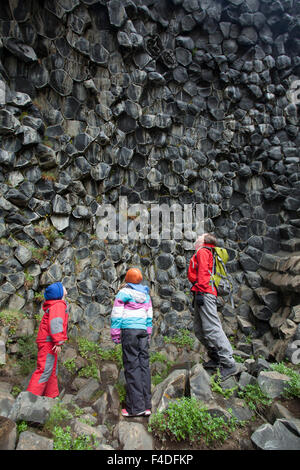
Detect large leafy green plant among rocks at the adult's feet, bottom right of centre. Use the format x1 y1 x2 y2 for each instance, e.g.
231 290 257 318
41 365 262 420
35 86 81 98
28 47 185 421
148 397 240 445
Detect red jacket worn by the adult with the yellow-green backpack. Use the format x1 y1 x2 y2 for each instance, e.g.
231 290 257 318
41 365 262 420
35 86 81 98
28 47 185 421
192 243 217 296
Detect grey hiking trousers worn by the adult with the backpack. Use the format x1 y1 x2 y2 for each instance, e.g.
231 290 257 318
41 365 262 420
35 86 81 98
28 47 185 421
194 294 235 367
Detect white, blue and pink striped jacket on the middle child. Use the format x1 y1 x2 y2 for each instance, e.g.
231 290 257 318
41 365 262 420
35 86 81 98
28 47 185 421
110 284 153 343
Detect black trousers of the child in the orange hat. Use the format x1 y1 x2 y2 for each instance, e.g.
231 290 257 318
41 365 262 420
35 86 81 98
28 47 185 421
121 328 151 414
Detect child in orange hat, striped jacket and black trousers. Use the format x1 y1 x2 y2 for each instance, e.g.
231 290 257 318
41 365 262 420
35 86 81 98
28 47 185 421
111 268 153 417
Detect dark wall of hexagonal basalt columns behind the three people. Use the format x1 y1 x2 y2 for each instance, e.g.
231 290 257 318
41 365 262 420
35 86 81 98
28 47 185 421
0 0 300 359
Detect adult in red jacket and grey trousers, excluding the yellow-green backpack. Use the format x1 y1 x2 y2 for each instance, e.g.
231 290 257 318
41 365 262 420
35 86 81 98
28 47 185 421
192 233 237 379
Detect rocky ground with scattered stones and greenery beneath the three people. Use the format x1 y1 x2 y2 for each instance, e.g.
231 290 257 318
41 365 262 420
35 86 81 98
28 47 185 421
0 324 300 450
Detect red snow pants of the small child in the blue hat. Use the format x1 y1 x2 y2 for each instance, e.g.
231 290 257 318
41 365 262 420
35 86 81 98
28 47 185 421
27 342 59 398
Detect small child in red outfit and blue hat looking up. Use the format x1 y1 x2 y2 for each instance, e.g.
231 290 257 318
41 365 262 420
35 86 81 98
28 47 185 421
27 282 68 398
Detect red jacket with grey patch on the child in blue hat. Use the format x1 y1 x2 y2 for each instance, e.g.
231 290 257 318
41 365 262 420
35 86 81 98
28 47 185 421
36 300 69 346
